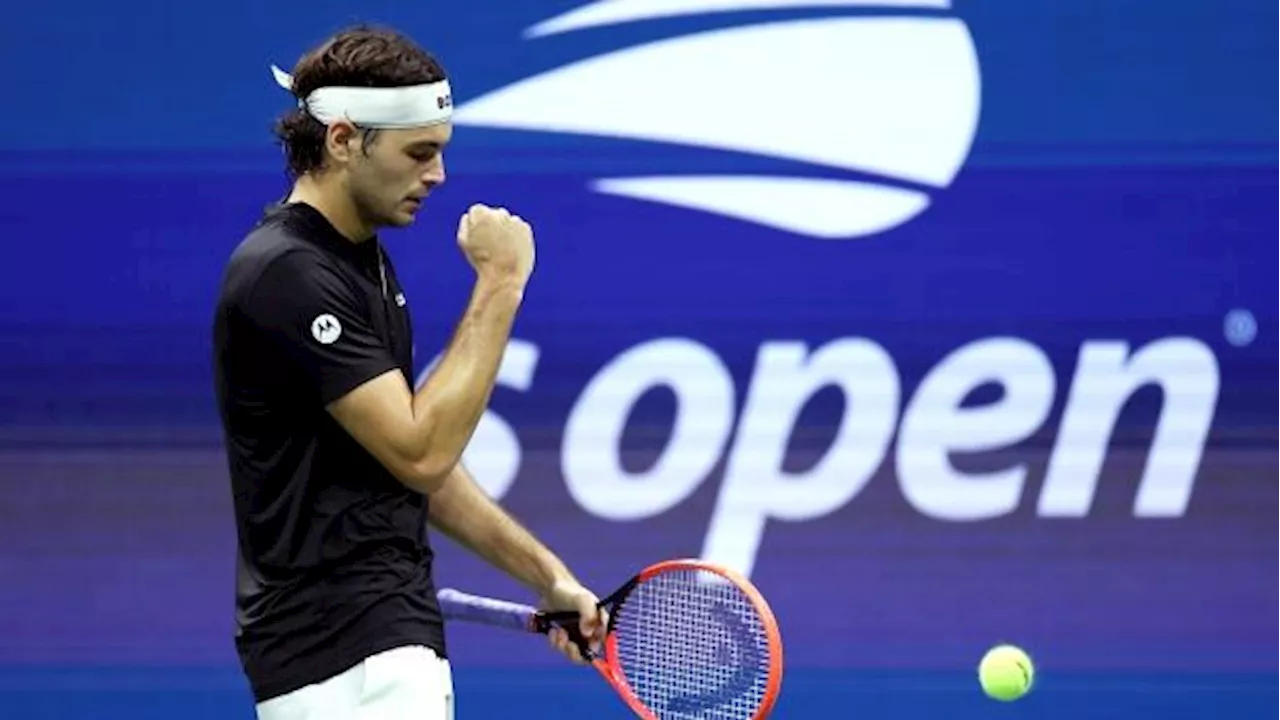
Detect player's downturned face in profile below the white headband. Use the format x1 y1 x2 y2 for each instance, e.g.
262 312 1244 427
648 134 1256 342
347 123 453 227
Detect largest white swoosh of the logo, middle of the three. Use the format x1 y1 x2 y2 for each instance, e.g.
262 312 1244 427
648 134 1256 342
453 18 978 186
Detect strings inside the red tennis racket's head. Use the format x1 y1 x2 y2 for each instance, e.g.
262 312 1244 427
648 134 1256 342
614 569 769 720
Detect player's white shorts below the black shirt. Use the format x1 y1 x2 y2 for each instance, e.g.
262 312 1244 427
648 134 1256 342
257 646 453 720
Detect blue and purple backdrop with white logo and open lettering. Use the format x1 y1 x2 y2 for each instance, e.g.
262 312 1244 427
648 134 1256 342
0 0 1280 719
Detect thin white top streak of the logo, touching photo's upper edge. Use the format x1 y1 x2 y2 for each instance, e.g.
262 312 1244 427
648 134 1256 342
525 0 951 37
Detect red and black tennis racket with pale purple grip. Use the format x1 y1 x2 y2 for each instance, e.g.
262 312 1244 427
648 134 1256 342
438 560 782 720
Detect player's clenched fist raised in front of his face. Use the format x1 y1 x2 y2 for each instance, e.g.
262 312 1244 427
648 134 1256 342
458 204 534 286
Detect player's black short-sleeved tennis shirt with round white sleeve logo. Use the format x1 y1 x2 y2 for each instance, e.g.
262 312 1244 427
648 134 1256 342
212 204 445 702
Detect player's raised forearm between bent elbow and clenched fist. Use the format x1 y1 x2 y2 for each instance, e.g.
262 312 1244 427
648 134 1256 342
412 282 522 475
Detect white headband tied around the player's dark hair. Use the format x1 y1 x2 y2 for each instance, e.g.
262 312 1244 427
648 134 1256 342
271 65 453 128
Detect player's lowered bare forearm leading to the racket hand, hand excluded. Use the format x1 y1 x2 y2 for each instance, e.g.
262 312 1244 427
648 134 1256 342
430 464 573 594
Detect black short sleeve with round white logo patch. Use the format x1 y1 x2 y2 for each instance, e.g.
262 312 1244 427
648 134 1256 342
243 250 398 405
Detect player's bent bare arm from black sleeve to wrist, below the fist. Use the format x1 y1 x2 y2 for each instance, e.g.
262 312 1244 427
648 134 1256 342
329 279 522 493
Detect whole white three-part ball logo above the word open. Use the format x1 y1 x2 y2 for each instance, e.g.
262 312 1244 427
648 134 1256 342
453 0 980 240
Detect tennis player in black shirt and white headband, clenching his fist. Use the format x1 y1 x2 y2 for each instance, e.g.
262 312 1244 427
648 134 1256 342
212 27 605 720
